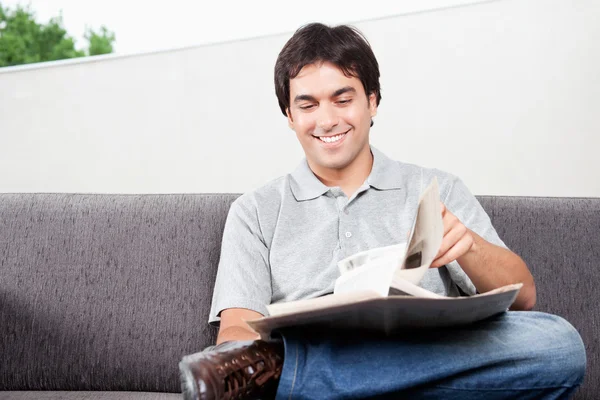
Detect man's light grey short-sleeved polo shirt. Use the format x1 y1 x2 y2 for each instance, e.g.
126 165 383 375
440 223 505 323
209 147 506 325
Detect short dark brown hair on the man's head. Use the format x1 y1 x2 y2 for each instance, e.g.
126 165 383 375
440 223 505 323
275 23 381 115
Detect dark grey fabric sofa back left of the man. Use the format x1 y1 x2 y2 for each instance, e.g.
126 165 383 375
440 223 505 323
0 194 234 392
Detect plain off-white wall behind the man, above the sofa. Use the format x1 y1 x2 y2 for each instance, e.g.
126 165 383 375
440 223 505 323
0 0 600 197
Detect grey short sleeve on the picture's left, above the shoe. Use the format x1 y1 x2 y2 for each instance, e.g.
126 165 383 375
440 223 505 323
208 196 272 326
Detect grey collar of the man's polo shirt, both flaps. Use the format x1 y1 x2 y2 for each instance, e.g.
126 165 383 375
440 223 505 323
290 146 403 201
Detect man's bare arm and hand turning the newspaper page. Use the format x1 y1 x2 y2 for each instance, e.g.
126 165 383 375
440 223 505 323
431 205 536 310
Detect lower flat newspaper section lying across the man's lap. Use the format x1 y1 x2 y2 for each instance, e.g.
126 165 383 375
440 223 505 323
246 283 523 338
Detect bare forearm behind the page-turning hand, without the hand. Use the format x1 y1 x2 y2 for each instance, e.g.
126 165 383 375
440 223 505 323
457 232 536 310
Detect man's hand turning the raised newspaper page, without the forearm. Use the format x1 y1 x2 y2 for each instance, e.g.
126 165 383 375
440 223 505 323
431 203 475 268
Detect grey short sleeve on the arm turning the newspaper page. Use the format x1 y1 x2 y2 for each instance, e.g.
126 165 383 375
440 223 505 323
443 176 507 295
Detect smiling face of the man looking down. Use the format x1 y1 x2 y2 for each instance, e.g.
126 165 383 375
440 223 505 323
287 63 377 173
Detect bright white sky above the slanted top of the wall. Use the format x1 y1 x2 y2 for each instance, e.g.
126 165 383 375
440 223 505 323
2 0 498 54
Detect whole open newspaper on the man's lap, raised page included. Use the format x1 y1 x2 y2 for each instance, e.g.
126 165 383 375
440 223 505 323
246 179 522 337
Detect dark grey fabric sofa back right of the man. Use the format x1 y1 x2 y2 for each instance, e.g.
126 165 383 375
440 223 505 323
479 196 600 399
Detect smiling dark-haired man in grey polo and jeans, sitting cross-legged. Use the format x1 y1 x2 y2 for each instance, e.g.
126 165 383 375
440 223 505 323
180 24 585 399
